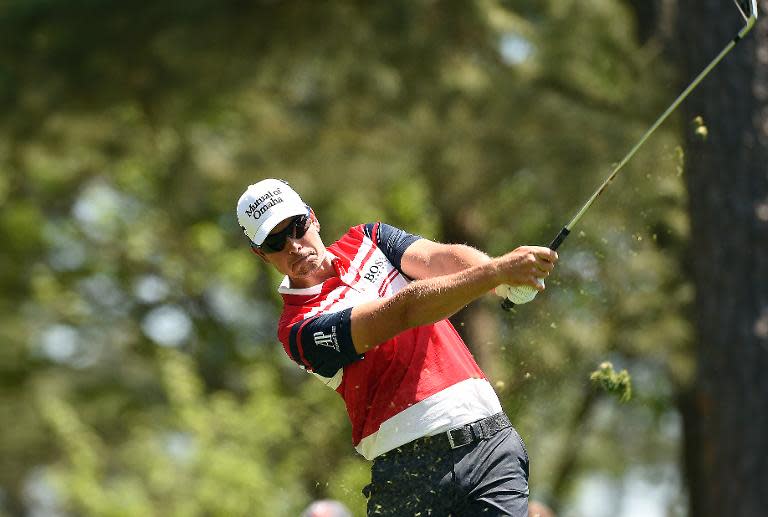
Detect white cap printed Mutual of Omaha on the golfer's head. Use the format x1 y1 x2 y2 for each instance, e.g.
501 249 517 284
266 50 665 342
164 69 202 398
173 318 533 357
237 179 307 245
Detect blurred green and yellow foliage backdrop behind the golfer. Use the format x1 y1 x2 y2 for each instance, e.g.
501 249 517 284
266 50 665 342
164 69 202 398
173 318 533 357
0 0 764 516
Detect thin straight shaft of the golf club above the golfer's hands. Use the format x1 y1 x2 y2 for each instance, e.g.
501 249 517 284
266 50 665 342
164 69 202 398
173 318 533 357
501 8 756 311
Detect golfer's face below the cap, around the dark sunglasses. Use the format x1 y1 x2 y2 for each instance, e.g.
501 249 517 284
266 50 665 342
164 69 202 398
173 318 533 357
254 212 325 287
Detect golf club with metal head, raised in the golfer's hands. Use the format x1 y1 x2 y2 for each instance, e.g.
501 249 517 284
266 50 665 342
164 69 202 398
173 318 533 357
496 0 757 311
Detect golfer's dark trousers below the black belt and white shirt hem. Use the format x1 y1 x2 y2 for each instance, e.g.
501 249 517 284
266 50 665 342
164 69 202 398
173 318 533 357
363 427 528 517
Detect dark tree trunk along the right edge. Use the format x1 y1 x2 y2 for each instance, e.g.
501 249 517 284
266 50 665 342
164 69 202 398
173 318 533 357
678 0 768 517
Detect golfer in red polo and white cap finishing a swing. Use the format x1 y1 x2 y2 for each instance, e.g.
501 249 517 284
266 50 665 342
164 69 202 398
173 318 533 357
237 179 557 517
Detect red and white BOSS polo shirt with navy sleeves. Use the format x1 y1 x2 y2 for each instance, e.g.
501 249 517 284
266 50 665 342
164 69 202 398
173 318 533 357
278 223 501 459
